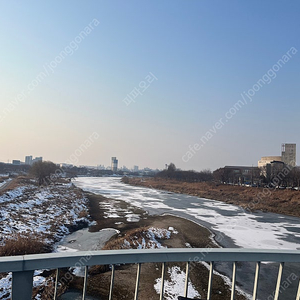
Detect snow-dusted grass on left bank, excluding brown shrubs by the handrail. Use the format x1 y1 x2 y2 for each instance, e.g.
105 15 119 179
0 184 88 245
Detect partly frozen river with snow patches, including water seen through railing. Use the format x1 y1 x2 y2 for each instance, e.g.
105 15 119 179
74 177 300 300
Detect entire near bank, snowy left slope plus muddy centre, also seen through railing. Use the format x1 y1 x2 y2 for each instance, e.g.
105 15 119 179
0 178 245 300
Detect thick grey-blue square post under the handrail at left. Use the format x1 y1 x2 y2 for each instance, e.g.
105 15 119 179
11 271 34 300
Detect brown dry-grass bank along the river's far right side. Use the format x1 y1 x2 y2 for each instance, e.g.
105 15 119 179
122 177 300 217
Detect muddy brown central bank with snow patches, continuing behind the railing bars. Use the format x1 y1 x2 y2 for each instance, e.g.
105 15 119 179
58 193 246 300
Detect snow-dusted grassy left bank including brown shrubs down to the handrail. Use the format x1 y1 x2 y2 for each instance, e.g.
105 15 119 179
0 178 89 256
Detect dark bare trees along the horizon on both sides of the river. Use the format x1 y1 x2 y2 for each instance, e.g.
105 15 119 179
6 161 300 187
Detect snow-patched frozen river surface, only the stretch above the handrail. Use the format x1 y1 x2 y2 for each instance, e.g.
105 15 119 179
75 177 300 250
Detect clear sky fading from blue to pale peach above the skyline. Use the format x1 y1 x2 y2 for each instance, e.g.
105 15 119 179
0 0 300 171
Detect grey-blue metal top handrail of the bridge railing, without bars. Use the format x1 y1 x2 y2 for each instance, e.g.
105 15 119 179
0 248 300 272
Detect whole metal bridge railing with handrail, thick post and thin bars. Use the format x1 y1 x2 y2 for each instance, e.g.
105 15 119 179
0 248 300 300
